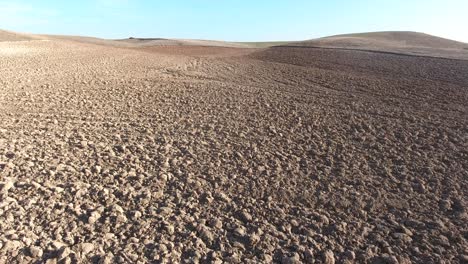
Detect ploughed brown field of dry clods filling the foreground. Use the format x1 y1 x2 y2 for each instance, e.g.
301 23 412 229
0 40 468 264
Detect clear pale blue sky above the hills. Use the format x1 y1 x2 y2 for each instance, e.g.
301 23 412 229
0 0 468 43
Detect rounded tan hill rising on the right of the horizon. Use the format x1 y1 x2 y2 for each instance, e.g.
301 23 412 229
294 31 468 49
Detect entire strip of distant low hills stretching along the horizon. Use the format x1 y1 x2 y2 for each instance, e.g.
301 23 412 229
0 30 468 59
